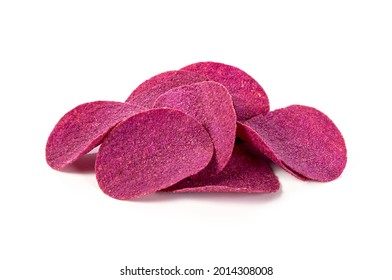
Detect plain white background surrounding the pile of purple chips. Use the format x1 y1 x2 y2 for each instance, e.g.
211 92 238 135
0 0 392 280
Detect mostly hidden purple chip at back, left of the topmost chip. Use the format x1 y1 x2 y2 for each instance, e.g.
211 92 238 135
126 70 207 108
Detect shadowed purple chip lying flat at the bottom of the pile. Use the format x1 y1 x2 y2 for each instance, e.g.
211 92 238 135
164 142 279 193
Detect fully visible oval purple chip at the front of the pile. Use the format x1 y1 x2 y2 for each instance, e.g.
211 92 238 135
95 108 213 199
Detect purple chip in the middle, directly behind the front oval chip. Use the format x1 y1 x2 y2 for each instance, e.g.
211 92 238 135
154 82 237 178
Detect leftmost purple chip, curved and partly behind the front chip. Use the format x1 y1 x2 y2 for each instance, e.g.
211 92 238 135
46 101 145 170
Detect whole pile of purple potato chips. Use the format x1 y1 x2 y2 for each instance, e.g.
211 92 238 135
46 62 347 200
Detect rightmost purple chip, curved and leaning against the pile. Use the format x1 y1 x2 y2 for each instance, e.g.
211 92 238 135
237 105 347 182
